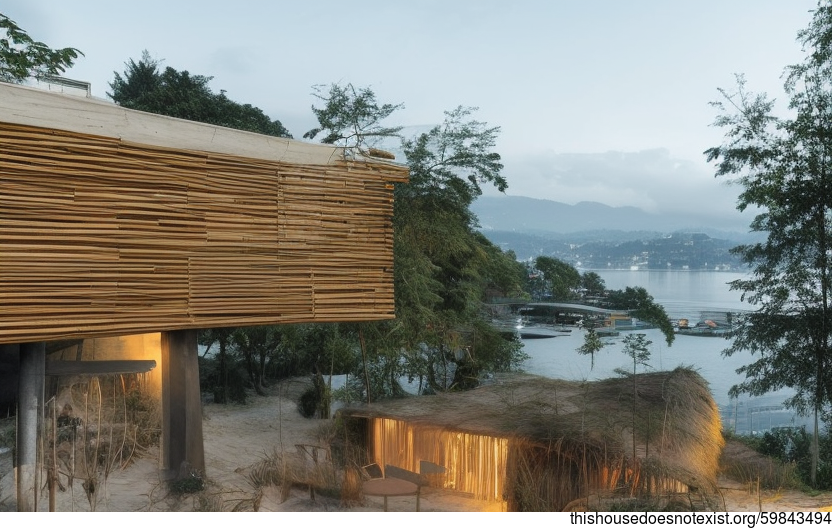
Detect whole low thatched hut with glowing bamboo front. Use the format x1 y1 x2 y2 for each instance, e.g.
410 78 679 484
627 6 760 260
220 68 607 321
341 368 724 511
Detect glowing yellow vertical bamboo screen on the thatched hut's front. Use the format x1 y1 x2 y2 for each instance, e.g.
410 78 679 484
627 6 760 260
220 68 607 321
371 418 508 501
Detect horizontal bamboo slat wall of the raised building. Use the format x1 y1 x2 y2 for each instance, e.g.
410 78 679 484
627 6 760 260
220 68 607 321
0 89 407 343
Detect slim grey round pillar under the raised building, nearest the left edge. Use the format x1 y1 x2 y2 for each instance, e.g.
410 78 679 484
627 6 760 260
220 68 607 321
16 342 46 512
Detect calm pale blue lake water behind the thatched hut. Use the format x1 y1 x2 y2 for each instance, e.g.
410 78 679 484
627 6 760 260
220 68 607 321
523 270 811 433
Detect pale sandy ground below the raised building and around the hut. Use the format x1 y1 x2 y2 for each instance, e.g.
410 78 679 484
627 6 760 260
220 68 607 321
0 384 832 512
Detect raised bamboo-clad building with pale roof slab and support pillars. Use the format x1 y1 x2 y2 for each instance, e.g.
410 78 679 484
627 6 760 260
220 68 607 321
0 83 408 511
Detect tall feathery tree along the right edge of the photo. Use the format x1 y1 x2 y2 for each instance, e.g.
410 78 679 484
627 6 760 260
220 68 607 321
705 1 832 484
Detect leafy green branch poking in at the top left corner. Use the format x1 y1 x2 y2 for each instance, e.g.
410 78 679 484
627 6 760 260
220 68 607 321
0 13 84 83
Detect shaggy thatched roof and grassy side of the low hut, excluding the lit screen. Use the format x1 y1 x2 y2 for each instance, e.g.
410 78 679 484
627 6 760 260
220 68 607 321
345 368 723 509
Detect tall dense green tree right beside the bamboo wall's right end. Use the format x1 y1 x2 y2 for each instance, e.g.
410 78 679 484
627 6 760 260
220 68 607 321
394 106 525 390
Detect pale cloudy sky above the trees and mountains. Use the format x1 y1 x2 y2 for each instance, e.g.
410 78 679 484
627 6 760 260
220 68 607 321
0 0 817 229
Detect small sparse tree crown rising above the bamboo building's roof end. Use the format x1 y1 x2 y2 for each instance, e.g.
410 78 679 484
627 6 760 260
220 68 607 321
303 84 404 151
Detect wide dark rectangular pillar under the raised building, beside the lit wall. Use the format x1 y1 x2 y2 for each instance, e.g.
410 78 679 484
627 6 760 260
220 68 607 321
160 330 205 480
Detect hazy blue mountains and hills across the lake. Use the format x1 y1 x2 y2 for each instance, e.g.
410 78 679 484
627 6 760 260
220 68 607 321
471 196 761 270
